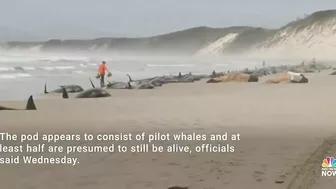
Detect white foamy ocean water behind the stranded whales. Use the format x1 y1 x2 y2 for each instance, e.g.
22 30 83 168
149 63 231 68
0 52 296 100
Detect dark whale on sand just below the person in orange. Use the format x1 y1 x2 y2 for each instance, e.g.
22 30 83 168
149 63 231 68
62 78 111 99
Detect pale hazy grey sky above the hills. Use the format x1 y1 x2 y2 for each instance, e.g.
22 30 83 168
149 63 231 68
0 0 336 37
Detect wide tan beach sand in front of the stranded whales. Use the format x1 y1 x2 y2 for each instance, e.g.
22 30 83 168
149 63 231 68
0 71 336 189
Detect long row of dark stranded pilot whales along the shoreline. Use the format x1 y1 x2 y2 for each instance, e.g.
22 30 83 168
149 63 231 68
0 64 328 110
